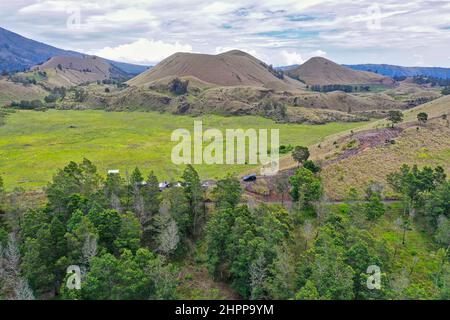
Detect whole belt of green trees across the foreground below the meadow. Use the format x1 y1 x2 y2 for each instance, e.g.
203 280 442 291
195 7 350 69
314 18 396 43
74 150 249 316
0 158 450 299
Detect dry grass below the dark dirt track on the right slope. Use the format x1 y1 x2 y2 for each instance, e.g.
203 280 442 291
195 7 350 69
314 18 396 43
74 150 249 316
321 120 450 199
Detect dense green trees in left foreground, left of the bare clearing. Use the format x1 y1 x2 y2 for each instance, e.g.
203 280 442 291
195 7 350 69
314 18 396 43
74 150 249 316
0 159 204 299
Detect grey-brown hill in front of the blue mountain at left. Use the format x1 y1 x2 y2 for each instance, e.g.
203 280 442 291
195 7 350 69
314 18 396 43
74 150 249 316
32 56 129 87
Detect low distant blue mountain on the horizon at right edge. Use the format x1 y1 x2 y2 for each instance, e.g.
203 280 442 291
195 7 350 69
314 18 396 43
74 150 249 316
345 64 450 79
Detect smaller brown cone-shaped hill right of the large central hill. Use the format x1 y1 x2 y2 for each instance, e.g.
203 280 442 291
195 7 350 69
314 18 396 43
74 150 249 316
287 57 393 86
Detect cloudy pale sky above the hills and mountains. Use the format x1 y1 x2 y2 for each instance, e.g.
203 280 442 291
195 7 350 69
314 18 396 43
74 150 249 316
0 0 450 67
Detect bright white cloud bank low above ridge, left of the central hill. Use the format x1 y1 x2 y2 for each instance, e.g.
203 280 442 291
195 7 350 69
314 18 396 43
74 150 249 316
94 39 192 64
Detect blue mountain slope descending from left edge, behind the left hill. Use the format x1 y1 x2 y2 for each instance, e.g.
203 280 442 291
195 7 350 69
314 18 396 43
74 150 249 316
0 27 147 76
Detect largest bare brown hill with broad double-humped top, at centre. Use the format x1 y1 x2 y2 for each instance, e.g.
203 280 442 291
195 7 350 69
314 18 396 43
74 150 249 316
128 50 301 90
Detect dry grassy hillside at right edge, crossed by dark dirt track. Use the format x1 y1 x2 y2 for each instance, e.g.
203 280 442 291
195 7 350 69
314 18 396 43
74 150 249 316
274 96 450 200
